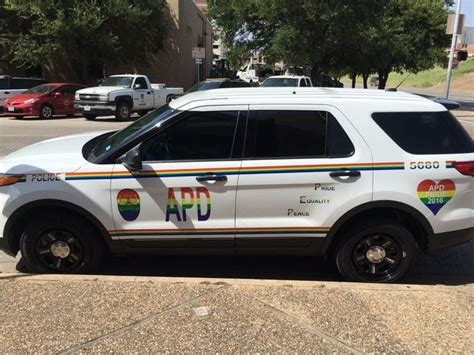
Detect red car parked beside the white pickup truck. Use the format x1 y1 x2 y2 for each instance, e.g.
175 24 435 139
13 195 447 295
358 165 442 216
3 83 85 119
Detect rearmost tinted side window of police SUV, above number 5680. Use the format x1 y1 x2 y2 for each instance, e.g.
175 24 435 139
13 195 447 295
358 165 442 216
372 111 474 154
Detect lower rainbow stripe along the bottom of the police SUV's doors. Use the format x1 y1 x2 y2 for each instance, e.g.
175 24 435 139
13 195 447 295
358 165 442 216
109 227 330 239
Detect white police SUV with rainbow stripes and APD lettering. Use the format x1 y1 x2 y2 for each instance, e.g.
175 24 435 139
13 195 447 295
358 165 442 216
0 88 474 282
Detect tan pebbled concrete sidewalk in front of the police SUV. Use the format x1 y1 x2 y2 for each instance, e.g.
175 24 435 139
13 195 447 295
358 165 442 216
0 274 474 353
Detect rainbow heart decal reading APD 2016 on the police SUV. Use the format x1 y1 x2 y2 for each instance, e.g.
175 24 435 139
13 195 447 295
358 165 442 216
417 180 456 215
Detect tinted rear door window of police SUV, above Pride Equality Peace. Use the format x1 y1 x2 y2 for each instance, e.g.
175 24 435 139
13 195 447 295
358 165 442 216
245 111 354 159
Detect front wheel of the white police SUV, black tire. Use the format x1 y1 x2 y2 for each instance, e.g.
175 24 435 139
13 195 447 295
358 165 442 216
20 214 104 274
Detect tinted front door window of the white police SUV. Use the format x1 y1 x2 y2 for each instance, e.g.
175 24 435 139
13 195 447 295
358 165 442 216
142 111 238 161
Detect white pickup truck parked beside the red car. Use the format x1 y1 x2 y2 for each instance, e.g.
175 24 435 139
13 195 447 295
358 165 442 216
74 74 183 120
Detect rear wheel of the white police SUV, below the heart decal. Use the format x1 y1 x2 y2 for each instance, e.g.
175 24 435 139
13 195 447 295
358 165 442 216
335 221 417 282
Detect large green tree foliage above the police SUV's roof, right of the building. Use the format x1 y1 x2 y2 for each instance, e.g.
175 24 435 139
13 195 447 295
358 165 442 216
209 0 448 88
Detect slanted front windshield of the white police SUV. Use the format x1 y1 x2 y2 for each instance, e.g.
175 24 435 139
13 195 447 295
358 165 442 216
87 105 176 162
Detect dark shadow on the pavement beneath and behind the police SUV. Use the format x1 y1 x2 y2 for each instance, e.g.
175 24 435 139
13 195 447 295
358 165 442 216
98 243 474 285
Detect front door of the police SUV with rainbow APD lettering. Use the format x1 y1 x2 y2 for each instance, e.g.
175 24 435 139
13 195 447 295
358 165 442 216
111 107 247 253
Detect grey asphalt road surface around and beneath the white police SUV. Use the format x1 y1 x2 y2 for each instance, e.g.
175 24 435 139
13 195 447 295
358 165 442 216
0 111 474 285
